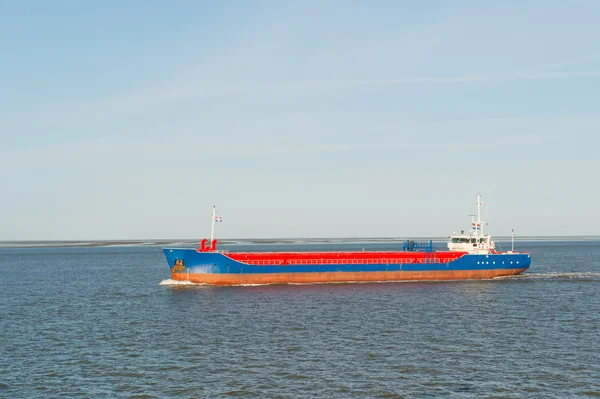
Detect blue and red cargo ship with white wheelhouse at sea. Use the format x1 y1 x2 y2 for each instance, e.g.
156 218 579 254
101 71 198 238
163 194 531 285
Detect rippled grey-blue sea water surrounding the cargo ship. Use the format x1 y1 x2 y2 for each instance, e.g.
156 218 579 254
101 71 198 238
0 241 600 398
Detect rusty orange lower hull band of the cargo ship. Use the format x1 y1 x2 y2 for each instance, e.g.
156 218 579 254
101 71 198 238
171 269 526 285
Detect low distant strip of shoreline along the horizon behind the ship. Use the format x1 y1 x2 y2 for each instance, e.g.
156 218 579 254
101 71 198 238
0 236 600 248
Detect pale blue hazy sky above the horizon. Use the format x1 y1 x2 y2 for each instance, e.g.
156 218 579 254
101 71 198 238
0 0 600 240
